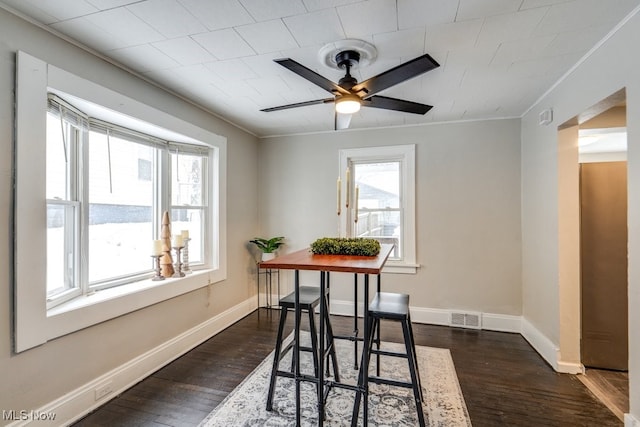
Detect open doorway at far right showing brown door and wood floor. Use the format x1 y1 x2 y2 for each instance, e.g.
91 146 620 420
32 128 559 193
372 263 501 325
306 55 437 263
578 101 629 420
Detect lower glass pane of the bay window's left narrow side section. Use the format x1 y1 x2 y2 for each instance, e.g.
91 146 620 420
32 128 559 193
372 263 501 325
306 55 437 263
47 204 78 297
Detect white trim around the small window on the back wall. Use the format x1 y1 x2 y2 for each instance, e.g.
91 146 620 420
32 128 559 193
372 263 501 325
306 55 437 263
339 144 420 274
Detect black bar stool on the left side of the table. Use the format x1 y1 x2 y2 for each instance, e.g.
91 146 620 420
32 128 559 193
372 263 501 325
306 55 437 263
267 286 340 411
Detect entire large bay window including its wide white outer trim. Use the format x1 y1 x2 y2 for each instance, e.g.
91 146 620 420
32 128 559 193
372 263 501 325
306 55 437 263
12 52 226 352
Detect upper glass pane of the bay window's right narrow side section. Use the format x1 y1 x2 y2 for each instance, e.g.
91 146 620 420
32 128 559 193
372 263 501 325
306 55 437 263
171 153 205 206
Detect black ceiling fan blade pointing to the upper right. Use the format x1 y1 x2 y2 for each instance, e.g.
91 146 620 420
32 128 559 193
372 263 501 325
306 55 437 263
351 54 440 99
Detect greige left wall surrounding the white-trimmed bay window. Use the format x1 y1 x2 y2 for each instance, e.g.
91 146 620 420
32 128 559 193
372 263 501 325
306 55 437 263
0 9 258 425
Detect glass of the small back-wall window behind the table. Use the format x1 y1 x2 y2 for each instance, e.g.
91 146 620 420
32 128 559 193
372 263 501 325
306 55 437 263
354 162 402 259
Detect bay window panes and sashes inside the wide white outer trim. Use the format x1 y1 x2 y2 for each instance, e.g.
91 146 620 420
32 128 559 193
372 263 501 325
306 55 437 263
46 94 215 307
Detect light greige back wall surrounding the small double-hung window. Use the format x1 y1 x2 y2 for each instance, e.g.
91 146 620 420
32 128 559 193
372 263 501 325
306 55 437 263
260 118 521 316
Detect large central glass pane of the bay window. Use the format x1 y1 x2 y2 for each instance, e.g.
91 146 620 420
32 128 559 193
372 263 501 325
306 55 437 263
89 132 154 283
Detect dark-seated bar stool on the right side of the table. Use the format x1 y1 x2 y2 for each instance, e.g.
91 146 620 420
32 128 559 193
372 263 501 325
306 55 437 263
354 292 425 427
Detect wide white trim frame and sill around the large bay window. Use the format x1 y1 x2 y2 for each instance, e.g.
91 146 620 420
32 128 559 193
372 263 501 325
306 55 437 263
13 52 227 353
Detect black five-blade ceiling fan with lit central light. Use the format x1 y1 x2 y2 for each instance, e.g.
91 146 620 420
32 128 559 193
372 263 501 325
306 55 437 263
260 50 440 130
